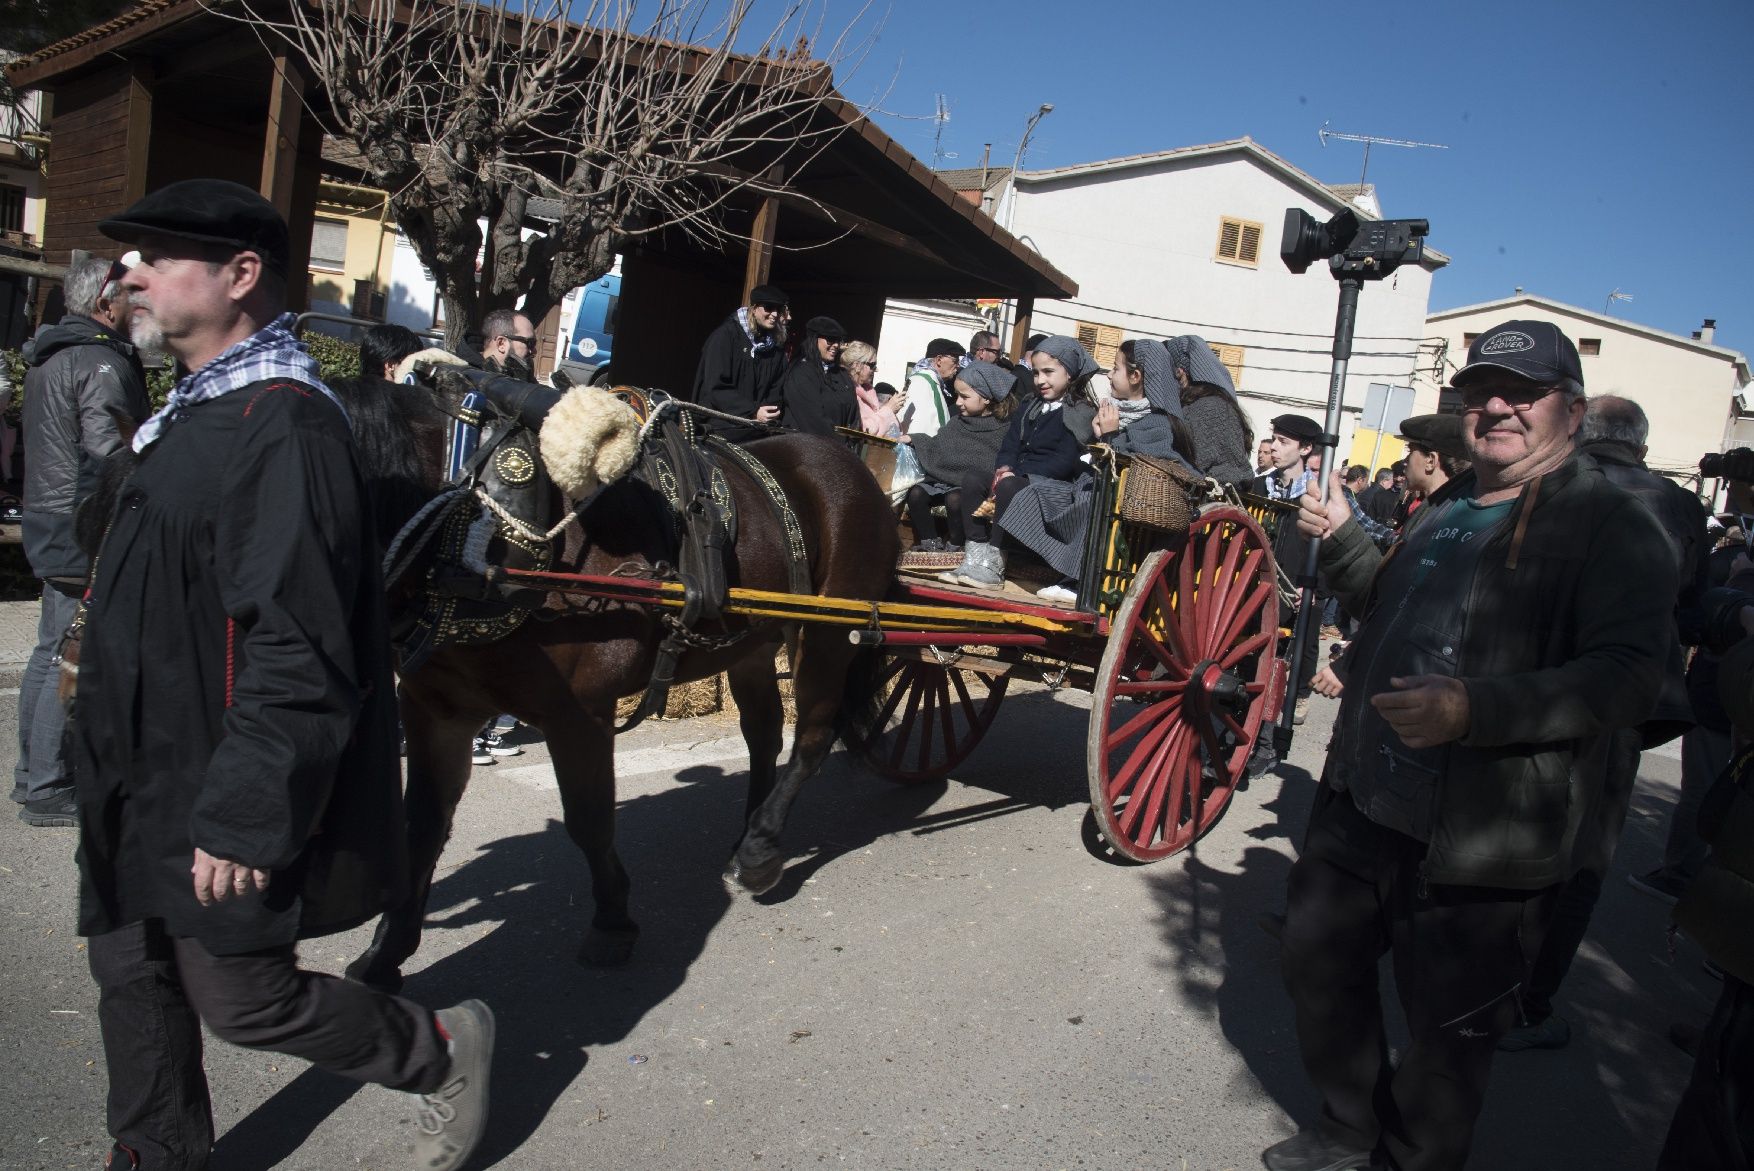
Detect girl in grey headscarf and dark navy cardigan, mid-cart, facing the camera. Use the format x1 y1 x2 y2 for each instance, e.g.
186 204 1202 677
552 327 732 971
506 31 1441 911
942 337 1098 589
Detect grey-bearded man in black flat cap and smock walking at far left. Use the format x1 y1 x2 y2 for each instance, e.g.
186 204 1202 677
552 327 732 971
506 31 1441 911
72 179 493 1171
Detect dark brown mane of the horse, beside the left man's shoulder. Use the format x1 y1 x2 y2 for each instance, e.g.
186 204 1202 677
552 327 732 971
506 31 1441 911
330 379 446 547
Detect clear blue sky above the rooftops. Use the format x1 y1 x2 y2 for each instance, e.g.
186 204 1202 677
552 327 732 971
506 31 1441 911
813 0 1754 352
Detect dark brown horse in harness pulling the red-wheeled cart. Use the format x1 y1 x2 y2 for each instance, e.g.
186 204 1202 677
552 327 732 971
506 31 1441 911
339 380 898 987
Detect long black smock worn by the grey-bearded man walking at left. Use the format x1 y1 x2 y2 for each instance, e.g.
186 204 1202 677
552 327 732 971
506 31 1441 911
72 380 407 955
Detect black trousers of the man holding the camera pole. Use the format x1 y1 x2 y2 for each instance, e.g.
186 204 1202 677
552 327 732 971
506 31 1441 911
1282 784 1558 1171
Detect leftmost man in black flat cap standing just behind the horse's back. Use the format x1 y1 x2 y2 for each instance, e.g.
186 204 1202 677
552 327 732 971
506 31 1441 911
693 284 788 444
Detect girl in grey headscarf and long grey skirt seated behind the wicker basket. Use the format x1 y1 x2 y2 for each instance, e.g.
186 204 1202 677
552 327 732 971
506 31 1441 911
998 338 1198 601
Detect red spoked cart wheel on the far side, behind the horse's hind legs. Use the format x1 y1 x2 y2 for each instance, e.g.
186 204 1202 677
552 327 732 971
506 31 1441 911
847 647 1010 785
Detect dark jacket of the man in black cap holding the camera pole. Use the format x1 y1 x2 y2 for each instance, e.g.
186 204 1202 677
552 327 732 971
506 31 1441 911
1321 456 1675 891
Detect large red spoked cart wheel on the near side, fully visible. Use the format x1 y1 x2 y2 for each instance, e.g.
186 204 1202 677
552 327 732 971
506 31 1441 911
1089 505 1279 862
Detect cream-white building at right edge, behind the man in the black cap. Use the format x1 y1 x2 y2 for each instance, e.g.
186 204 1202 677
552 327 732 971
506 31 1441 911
1426 293 1754 479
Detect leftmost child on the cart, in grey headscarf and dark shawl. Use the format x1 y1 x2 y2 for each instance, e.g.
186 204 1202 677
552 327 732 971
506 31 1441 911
902 361 1017 553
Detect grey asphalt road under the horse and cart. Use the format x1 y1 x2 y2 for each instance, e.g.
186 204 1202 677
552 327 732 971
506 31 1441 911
0 689 1717 1171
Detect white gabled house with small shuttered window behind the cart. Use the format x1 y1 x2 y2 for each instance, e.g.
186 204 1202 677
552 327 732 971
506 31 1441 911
919 138 1447 456
